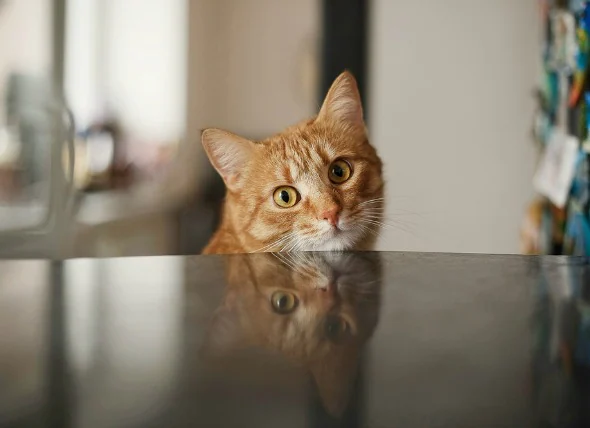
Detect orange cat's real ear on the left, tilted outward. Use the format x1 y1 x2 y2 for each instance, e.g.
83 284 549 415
201 128 254 189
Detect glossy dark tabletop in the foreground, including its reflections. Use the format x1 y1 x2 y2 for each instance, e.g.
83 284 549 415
0 253 590 428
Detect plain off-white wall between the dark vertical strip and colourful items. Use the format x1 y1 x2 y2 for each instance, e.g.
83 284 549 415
370 0 540 253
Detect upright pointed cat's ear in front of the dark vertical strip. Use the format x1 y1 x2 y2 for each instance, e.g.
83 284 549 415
317 71 364 126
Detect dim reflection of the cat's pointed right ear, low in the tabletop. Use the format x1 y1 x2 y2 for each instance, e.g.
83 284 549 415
309 349 358 417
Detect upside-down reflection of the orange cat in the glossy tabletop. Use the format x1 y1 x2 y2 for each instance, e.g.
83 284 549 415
204 253 381 416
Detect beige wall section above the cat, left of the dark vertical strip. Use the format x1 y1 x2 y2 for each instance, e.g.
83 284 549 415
188 0 320 138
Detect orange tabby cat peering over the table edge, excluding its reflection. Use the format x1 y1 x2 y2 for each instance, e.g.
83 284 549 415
202 72 384 254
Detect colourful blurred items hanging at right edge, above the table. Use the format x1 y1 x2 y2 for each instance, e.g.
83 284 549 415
521 0 590 256
